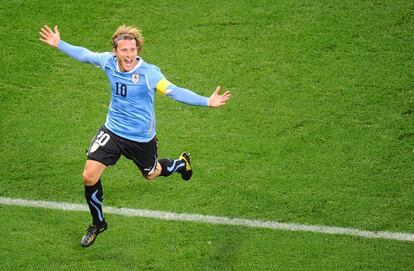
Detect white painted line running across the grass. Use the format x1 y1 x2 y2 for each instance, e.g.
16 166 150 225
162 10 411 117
0 197 414 242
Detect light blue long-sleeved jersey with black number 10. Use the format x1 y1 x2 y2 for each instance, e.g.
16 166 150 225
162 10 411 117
58 41 208 142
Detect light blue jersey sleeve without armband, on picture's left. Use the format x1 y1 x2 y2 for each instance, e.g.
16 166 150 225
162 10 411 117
58 40 112 67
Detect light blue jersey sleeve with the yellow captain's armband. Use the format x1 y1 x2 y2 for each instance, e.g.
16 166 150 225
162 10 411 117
148 66 208 106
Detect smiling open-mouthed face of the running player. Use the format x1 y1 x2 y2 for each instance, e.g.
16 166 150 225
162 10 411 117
114 40 138 72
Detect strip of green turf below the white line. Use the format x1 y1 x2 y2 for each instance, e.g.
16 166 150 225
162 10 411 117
0 206 414 270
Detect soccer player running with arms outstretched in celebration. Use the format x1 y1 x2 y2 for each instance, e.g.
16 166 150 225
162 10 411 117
39 25 231 247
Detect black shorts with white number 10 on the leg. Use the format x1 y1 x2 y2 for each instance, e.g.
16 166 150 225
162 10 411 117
87 125 158 175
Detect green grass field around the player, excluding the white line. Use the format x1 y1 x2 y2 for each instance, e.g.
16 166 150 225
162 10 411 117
0 0 414 270
